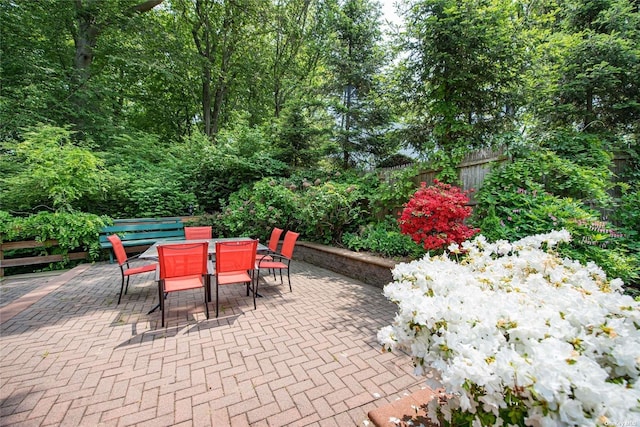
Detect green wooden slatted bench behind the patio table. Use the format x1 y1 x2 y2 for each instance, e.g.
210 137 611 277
100 217 184 262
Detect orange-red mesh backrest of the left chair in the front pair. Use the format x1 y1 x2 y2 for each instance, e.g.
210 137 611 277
158 242 209 279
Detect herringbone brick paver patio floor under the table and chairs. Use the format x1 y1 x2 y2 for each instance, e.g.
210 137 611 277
0 261 424 427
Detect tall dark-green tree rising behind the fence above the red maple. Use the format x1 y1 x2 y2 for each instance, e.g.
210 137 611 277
399 0 524 162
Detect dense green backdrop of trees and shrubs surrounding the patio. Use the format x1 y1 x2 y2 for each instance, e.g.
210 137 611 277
0 0 640 290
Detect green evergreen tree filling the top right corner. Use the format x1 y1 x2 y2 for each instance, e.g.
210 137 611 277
534 0 640 133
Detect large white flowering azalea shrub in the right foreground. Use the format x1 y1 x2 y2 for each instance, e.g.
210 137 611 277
378 230 640 427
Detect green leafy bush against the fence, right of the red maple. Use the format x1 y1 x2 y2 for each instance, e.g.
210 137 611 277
472 153 638 284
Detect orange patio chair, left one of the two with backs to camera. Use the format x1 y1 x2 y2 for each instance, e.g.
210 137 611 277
158 242 210 327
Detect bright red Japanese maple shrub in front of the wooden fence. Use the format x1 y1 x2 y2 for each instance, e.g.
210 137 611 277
398 180 480 250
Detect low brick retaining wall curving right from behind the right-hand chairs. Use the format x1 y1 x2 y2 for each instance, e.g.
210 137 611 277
294 242 397 288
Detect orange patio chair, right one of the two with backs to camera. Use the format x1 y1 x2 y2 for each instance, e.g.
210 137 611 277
215 240 258 317
